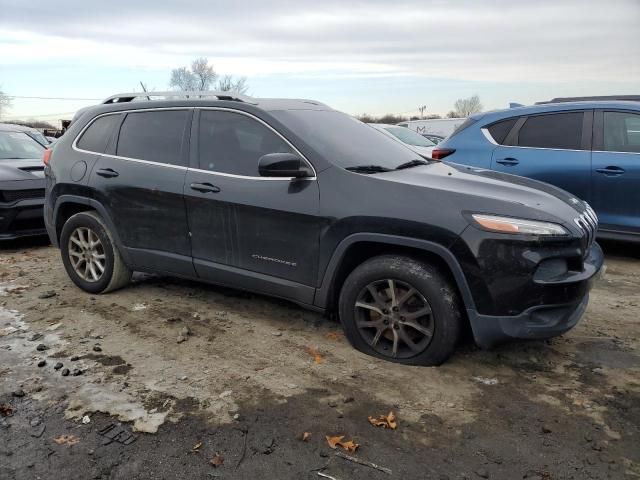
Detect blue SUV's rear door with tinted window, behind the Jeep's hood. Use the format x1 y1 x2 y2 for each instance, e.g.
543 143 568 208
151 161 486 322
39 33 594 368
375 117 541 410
491 110 593 201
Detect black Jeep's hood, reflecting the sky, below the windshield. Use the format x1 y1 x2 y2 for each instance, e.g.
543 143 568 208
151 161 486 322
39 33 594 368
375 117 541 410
375 162 586 223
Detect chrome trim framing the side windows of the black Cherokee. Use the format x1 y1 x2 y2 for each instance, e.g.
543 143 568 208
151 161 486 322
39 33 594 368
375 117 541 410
71 107 318 182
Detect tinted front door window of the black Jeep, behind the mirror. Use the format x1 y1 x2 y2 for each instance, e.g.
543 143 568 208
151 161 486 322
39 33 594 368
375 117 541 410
198 110 295 177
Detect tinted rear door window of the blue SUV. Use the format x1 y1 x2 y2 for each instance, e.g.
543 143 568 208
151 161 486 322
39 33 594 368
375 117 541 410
518 112 584 150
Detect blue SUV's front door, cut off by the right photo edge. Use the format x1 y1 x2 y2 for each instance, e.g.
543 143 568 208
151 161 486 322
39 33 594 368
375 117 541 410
591 110 640 233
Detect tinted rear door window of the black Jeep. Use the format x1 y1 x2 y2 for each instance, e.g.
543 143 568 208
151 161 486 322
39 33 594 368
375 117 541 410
116 110 188 165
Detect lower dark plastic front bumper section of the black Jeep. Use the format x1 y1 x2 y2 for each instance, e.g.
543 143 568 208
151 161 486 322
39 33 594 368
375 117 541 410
467 243 604 348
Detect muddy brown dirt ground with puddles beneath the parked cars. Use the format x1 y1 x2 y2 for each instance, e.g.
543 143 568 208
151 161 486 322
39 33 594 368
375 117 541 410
0 240 640 480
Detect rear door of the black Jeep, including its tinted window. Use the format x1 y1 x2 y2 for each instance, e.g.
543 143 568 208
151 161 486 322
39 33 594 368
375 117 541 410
90 108 195 275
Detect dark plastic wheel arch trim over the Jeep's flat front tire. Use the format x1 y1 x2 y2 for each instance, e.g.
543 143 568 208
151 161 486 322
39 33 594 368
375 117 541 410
314 233 475 314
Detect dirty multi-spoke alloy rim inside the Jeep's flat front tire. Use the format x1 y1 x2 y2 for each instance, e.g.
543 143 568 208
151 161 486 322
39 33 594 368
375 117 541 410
355 279 434 358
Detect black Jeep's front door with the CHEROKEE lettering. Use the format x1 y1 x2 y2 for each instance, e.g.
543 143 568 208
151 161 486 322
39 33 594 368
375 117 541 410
185 108 320 303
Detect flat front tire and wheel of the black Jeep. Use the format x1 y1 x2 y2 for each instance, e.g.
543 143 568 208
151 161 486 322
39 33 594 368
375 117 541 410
338 255 462 366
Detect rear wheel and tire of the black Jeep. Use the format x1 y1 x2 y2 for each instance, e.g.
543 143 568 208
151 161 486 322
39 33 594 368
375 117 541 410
60 211 131 293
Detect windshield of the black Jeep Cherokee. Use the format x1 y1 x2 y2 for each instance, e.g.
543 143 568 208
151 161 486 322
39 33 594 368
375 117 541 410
272 110 420 169
